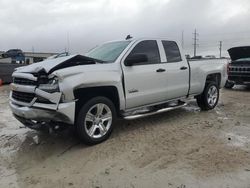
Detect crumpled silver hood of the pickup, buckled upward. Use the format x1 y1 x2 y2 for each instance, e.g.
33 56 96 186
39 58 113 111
15 55 99 74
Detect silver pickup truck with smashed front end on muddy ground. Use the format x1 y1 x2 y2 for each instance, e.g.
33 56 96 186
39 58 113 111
10 39 227 144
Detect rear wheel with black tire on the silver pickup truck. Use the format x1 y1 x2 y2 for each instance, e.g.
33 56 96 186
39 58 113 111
196 82 220 110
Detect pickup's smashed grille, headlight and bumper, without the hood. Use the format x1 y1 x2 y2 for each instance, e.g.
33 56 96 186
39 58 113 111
10 70 75 128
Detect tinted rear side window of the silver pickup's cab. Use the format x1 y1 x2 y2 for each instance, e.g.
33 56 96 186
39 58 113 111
162 40 182 63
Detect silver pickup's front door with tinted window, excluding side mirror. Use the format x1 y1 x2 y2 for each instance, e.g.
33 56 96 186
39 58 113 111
122 40 166 109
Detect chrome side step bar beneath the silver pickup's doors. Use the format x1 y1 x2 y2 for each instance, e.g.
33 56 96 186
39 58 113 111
123 102 187 120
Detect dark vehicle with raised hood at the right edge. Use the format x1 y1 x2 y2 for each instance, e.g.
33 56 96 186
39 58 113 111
225 46 250 88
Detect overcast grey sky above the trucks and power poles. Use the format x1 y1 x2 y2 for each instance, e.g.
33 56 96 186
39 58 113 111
0 0 250 56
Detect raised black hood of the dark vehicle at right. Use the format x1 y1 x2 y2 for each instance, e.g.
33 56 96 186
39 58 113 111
228 46 250 61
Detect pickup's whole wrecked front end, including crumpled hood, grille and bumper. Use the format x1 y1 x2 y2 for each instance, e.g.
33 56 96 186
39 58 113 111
10 55 102 131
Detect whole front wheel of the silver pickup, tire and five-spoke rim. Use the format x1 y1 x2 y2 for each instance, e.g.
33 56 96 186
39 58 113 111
76 97 116 145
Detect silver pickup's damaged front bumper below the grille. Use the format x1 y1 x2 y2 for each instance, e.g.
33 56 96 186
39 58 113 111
10 100 75 124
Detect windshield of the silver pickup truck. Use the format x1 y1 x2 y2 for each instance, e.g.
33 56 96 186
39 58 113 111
86 41 131 62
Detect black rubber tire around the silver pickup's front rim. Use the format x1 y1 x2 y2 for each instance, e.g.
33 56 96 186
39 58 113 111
76 97 116 145
